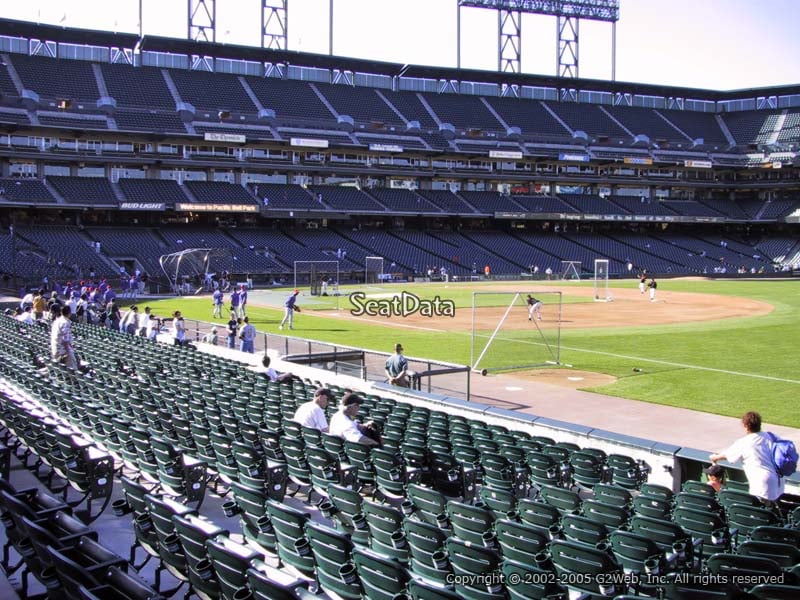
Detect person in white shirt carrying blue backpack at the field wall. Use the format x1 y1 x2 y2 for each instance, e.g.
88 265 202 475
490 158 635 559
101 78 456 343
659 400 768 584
709 411 797 506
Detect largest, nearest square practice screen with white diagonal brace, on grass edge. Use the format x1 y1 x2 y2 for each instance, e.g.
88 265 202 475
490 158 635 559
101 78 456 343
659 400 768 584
470 291 562 373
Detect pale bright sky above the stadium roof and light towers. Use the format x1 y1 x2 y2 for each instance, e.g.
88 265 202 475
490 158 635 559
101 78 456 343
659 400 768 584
2 0 800 89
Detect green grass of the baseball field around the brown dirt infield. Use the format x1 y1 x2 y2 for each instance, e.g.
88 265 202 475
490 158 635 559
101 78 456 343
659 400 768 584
144 280 800 427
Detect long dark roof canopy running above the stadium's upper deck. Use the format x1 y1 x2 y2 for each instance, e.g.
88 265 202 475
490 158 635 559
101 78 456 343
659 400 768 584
0 19 800 102
